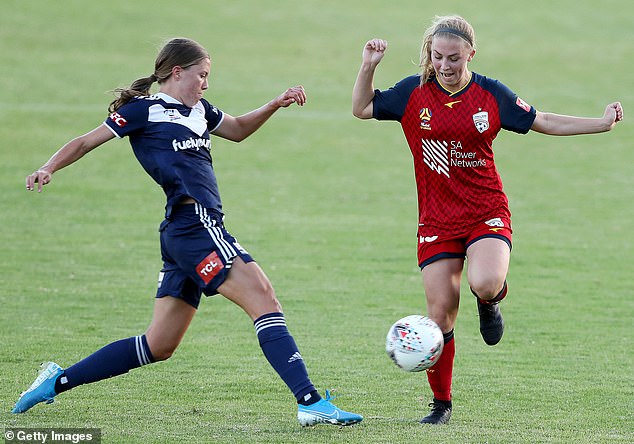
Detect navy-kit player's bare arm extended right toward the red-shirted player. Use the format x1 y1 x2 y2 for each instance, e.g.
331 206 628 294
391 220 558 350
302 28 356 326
213 86 306 142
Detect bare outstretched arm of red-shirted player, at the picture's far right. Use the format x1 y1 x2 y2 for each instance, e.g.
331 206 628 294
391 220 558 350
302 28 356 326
531 102 623 136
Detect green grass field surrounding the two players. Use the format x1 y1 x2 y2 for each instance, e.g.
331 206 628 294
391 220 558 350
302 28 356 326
0 0 634 443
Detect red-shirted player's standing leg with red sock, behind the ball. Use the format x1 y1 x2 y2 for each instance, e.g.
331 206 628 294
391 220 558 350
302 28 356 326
420 258 464 424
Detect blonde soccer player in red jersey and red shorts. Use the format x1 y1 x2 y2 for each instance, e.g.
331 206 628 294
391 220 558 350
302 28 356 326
352 16 623 424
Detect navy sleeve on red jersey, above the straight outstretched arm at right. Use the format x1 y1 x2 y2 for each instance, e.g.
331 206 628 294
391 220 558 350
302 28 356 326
478 79 537 134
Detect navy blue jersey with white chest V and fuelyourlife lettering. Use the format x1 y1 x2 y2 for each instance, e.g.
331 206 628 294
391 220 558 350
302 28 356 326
104 93 224 214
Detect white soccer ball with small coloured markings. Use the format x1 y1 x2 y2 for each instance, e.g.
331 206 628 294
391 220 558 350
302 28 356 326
385 315 444 372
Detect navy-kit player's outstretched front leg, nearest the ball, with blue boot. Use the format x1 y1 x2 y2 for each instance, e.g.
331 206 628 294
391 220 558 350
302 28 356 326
217 257 363 426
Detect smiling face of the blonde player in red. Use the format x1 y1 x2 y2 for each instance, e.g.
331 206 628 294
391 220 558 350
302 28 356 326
431 36 475 92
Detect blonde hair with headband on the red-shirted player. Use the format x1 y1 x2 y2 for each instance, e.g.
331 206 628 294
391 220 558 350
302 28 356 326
418 15 476 85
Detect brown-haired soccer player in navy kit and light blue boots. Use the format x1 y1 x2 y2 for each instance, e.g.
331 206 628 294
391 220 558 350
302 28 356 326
13 38 363 426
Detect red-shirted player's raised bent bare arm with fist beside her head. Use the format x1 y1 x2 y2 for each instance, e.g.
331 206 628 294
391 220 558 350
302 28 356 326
352 39 387 119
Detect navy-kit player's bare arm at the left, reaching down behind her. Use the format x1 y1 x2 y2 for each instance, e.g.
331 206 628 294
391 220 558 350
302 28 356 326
26 125 115 193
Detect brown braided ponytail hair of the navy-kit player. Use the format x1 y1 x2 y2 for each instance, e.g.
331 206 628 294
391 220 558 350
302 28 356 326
108 38 210 112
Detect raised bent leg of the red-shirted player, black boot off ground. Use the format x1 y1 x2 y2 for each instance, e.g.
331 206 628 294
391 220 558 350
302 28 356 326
467 237 511 345
